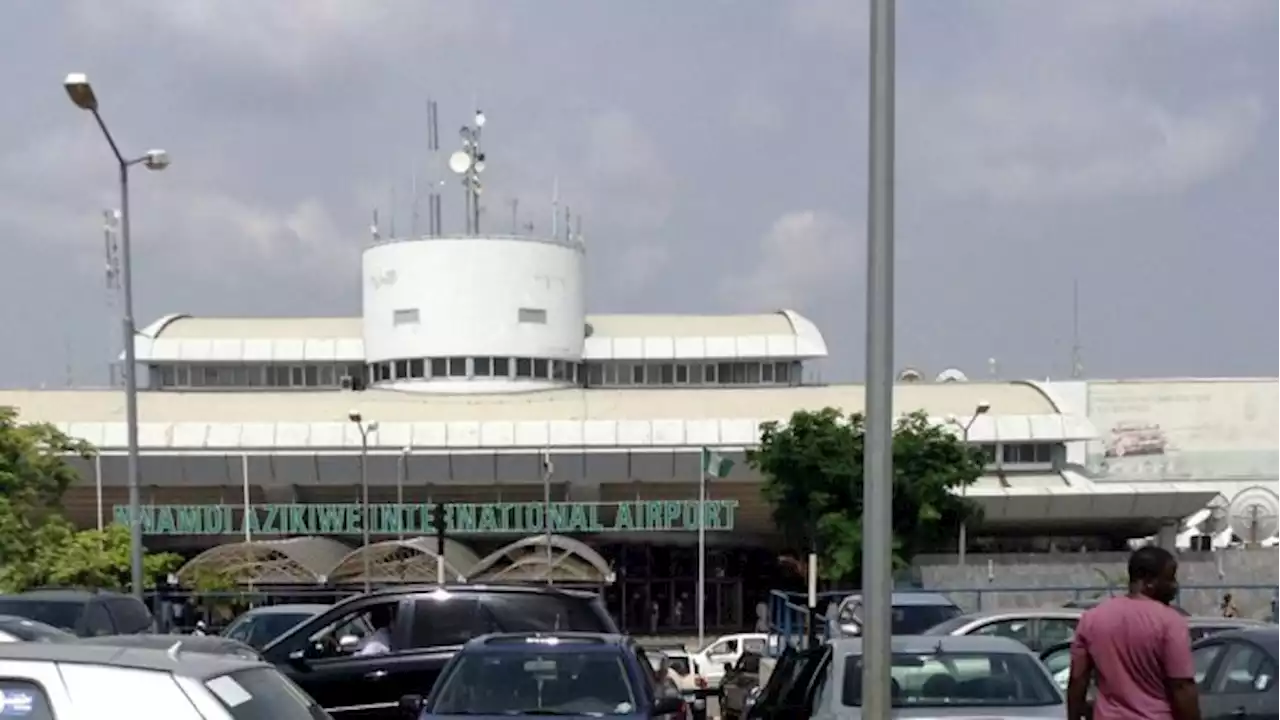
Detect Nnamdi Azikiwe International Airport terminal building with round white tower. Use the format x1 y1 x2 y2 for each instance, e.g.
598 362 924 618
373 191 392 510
0 228 1216 629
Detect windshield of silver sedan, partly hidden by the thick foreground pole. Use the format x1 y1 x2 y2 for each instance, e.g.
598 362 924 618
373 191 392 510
842 652 1062 707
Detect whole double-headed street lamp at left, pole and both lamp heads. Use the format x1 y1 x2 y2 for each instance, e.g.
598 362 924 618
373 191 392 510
63 73 169 600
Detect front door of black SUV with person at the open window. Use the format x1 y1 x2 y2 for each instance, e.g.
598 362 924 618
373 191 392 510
268 597 411 720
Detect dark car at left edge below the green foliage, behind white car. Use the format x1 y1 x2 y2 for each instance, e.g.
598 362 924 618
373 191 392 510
0 588 155 638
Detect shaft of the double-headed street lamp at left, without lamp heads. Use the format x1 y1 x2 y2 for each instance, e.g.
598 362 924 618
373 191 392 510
115 156 142 600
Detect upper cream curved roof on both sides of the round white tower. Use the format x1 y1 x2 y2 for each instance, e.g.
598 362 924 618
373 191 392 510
134 310 827 363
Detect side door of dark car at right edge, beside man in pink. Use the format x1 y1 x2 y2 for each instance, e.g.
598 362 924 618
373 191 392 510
1201 641 1280 720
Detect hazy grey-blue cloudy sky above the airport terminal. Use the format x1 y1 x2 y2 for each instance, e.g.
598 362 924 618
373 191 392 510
0 0 1280 387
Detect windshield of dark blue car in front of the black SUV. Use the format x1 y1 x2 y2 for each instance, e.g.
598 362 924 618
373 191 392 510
428 646 640 716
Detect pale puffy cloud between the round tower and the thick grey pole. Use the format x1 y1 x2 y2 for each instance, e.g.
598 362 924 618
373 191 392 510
718 210 863 310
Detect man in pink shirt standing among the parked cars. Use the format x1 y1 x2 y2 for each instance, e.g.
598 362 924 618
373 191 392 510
1066 546 1201 720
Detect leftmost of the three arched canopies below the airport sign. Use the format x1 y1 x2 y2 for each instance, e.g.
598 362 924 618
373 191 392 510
178 537 351 585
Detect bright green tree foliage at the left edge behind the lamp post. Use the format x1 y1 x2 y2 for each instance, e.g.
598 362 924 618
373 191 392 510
0 407 182 592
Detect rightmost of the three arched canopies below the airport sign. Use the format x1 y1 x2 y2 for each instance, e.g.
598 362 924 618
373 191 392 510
471 536 613 585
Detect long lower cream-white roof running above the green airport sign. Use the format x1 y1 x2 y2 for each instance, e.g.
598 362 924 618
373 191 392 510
0 383 1097 451
